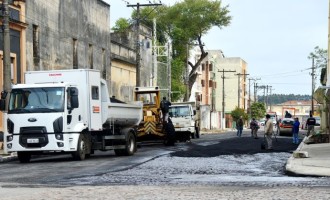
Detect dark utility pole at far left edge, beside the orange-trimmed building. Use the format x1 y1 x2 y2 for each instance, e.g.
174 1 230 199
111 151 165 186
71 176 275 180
0 0 11 110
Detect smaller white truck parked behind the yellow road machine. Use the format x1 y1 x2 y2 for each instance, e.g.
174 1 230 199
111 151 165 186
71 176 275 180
169 102 199 141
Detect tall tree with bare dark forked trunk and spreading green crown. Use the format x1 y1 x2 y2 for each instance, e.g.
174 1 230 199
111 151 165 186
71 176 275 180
163 0 231 100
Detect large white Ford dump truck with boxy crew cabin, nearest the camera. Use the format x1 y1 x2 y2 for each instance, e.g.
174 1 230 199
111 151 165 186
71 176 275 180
0 69 142 163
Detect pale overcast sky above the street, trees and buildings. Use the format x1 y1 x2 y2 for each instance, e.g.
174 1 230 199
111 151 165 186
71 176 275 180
105 0 329 95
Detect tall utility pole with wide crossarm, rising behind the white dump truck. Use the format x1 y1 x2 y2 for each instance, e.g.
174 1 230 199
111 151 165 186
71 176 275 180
127 3 162 87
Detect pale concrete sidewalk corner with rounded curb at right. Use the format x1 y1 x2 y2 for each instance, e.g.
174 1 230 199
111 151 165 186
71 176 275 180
285 137 330 176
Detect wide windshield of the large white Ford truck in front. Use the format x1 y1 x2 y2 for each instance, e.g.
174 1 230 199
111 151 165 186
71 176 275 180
8 87 65 113
